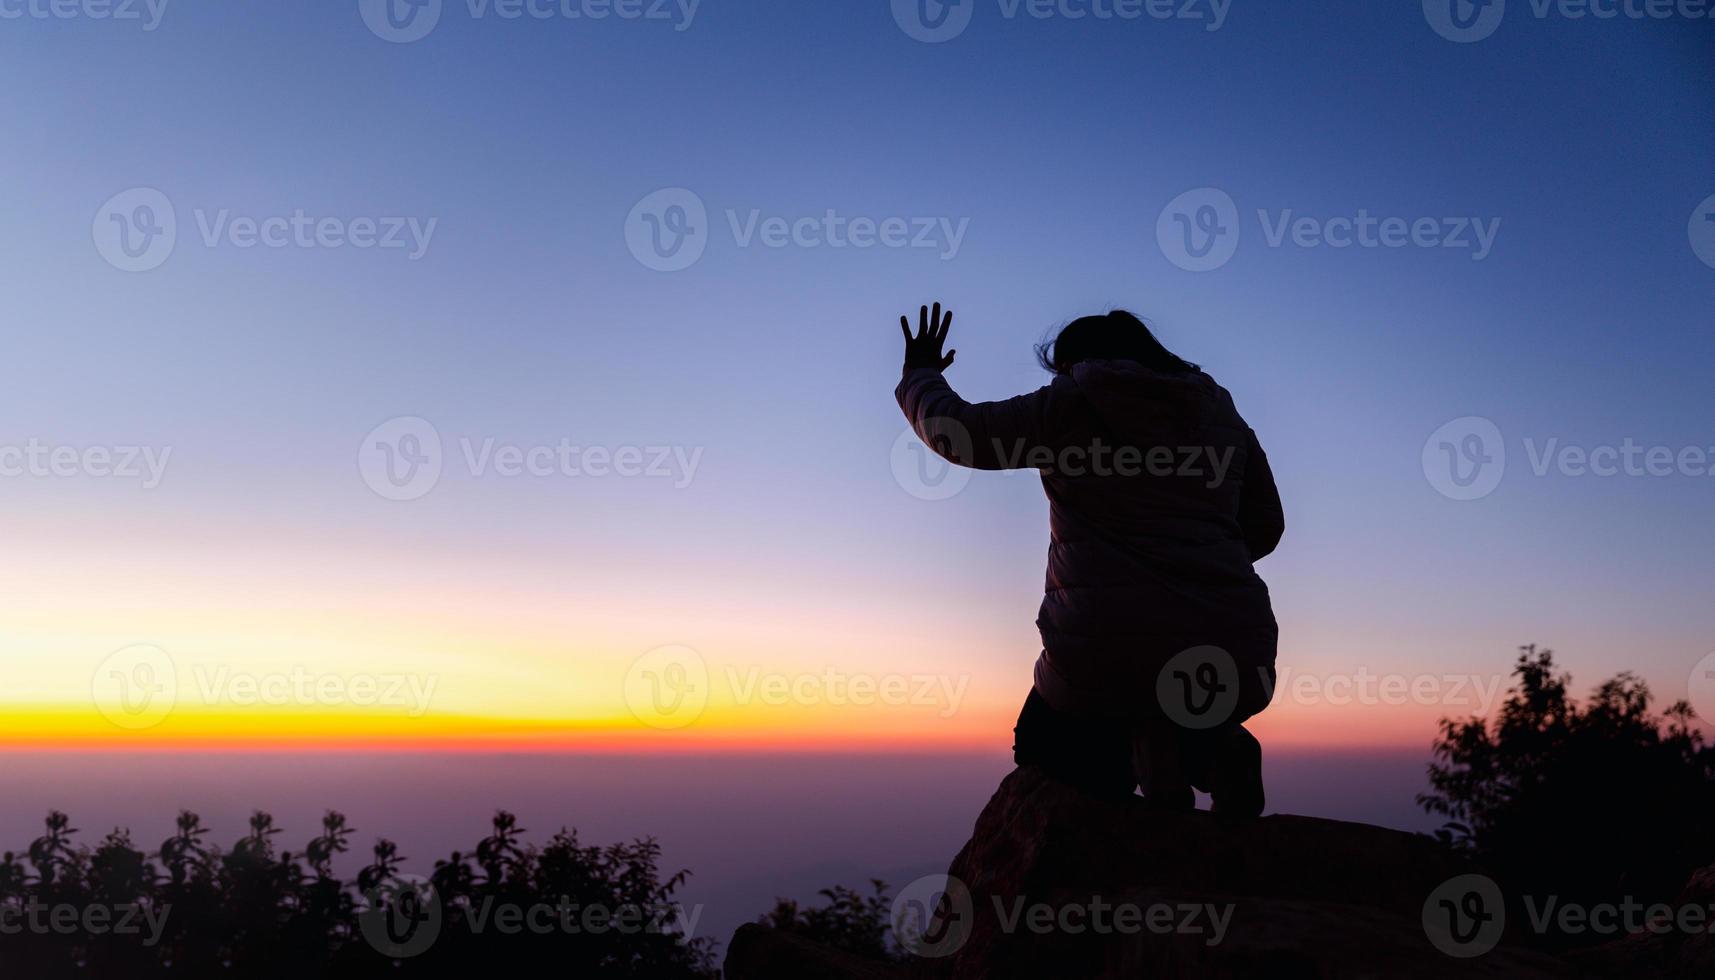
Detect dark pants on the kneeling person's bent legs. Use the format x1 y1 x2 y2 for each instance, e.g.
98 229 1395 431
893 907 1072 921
1012 688 1262 810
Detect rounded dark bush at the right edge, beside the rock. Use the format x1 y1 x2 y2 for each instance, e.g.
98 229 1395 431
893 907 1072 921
1418 645 1715 946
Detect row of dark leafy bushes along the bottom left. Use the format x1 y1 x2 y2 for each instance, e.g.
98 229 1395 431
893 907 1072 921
0 812 717 980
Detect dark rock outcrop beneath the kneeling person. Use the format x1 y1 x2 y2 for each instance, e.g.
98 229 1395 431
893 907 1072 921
725 767 1715 980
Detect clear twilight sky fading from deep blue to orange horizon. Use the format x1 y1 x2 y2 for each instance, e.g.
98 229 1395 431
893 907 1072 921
0 0 1715 748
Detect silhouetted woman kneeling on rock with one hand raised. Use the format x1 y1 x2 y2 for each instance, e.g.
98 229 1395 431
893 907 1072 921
895 304 1285 815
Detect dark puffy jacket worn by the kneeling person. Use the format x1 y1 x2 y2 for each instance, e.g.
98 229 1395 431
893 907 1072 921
895 360 1285 721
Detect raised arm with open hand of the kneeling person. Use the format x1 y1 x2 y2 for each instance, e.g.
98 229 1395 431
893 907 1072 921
894 304 1058 470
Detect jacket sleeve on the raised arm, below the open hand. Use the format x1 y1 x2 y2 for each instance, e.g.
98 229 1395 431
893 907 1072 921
894 367 1062 470
